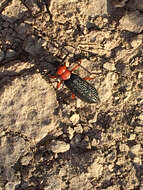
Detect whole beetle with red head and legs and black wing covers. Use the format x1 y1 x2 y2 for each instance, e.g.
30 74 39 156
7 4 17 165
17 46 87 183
50 62 100 103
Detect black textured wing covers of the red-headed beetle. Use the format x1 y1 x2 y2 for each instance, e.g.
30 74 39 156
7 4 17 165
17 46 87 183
64 74 99 103
